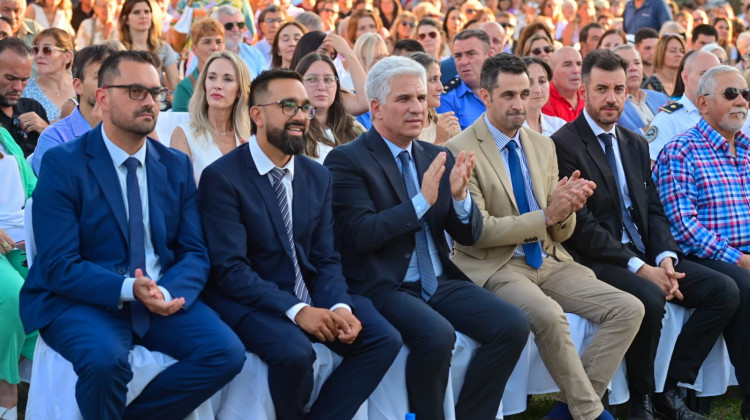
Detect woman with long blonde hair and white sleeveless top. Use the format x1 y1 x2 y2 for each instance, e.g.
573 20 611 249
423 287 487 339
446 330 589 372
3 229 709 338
171 51 250 184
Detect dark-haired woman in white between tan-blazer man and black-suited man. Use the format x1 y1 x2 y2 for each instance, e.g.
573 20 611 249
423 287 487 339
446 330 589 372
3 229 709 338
523 57 565 136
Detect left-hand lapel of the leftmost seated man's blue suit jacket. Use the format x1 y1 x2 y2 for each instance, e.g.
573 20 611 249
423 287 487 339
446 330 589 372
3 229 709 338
85 124 129 242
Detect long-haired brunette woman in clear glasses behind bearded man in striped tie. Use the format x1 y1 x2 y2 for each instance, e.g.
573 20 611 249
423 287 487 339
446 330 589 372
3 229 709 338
296 52 365 163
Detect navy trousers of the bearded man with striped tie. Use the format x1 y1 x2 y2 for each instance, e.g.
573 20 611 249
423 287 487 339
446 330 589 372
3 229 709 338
235 295 402 420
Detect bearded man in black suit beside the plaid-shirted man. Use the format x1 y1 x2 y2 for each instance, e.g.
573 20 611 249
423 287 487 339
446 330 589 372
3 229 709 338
552 50 739 420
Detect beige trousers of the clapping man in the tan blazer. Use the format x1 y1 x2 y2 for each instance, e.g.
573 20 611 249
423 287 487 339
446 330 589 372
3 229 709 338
485 257 644 420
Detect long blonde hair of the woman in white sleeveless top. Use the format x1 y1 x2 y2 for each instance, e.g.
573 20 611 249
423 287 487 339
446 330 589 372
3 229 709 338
188 51 250 141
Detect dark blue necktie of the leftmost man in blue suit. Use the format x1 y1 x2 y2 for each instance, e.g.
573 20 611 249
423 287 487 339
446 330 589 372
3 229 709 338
125 157 150 337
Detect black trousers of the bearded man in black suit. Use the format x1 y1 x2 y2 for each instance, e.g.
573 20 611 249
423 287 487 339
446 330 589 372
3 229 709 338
591 257 750 395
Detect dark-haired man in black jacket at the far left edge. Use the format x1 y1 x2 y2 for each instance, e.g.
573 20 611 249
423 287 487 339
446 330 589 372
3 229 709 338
0 38 49 157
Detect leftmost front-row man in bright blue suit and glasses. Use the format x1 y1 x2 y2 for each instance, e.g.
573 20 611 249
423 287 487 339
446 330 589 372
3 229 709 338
20 51 244 420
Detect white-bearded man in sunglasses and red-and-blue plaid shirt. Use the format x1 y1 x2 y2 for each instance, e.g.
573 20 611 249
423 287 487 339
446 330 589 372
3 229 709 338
653 66 750 419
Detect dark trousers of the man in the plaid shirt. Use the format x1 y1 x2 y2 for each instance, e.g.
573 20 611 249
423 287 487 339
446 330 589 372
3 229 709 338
690 257 750 395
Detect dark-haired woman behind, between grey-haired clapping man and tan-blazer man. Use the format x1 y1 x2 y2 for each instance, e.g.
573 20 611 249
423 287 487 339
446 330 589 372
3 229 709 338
407 52 461 144
